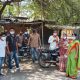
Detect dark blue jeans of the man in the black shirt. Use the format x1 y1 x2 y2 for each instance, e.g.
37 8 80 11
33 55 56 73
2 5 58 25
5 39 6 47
8 50 19 69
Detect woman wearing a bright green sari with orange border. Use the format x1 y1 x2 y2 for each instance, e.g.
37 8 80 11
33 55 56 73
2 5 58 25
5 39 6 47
66 37 80 79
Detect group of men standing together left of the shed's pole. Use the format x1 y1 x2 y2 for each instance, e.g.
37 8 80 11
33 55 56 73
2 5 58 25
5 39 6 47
0 28 41 75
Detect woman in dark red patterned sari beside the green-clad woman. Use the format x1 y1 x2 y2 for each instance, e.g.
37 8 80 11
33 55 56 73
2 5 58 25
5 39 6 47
59 33 68 72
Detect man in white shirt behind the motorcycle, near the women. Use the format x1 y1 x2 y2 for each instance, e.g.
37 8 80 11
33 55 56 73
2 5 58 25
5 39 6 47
48 31 59 50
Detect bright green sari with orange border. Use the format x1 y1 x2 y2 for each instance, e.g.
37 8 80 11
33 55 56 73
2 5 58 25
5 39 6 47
66 40 80 77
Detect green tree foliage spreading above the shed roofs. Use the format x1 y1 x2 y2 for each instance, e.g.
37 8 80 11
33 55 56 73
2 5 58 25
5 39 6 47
0 0 80 25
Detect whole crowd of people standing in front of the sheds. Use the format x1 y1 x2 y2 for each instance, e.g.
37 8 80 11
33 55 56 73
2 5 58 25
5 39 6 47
0 28 80 79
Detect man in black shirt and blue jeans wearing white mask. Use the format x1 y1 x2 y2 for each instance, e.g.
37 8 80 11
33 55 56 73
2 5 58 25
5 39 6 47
7 28 19 73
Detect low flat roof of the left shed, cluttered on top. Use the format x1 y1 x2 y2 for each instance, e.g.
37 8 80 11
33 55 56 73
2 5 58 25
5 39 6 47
0 17 55 25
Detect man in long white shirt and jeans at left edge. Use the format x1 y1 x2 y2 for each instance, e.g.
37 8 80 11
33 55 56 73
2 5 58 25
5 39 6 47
0 33 6 75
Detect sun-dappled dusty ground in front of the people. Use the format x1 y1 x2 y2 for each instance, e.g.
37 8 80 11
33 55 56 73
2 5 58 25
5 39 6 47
0 62 80 80
